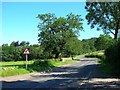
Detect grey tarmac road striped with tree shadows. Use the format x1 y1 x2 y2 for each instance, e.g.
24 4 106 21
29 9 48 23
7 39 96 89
2 57 120 90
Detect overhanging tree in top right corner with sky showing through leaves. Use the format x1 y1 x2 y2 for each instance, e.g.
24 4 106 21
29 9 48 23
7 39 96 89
85 2 120 39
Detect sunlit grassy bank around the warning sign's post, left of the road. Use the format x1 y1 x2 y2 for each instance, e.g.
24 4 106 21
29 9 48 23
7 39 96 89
0 59 79 77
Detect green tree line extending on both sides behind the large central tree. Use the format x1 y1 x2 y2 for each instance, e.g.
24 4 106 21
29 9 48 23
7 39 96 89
0 35 112 61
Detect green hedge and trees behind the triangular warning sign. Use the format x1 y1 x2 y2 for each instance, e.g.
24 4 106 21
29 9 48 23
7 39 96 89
1 41 43 61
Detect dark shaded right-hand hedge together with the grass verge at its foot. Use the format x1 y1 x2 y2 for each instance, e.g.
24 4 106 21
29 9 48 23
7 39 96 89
85 39 120 77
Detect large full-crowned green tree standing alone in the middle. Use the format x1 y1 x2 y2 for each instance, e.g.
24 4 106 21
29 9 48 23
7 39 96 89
38 13 83 58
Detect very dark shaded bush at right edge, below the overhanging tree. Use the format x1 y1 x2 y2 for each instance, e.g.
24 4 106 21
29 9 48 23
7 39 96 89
105 39 120 75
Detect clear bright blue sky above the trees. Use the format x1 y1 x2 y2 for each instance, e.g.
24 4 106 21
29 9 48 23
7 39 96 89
0 2 103 44
